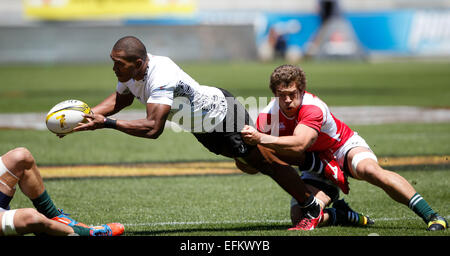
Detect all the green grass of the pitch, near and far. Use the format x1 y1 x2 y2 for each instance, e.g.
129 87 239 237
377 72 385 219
0 62 450 236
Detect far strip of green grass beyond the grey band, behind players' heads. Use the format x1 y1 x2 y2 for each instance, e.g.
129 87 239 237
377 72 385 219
0 62 450 113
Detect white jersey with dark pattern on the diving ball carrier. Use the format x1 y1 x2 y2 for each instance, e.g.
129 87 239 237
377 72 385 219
117 54 227 132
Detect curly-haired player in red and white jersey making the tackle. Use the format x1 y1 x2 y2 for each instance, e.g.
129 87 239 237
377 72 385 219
241 65 448 231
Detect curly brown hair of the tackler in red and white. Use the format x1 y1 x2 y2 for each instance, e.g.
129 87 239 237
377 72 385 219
270 64 306 94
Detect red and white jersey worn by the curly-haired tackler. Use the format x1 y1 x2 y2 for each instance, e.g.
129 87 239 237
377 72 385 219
256 92 354 153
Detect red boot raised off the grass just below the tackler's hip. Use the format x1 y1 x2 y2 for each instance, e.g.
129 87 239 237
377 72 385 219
319 151 350 194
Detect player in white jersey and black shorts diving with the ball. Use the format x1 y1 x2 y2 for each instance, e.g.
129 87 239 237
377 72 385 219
74 36 334 228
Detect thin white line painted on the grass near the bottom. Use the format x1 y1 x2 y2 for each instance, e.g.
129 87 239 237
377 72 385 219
123 215 450 227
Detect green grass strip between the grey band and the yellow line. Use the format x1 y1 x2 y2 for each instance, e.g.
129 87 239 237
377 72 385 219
0 123 450 165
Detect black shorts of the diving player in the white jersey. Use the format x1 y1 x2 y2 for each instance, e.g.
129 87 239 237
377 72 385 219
193 88 255 158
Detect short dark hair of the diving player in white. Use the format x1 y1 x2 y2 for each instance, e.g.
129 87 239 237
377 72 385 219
113 36 147 61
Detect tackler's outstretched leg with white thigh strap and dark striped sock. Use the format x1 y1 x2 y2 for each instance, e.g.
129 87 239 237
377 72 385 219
347 147 448 230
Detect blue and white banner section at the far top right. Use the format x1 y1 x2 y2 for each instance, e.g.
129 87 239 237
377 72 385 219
346 10 450 55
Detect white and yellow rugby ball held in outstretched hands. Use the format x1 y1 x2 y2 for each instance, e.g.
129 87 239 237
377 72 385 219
45 100 91 134
